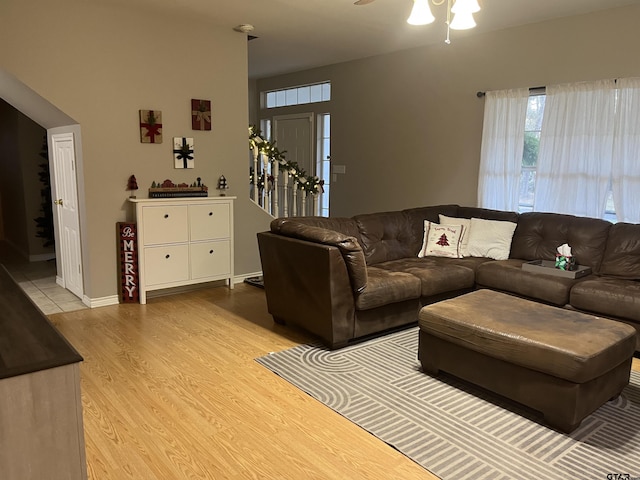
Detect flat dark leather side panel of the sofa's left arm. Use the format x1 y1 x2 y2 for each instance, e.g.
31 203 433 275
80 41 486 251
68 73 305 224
257 232 355 348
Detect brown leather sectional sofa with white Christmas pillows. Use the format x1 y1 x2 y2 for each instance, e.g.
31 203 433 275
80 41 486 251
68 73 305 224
258 205 640 351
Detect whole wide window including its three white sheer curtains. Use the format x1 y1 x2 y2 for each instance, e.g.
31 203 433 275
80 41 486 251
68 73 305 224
478 77 640 223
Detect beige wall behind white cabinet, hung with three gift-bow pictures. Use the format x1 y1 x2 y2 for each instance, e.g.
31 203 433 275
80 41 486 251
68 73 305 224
0 0 268 299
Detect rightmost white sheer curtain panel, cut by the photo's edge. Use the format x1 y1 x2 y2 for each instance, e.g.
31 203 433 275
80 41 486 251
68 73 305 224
612 78 640 223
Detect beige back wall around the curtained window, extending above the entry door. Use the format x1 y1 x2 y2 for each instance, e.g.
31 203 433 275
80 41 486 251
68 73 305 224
256 6 640 216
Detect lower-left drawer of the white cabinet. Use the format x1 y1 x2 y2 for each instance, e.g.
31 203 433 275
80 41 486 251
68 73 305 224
144 244 189 285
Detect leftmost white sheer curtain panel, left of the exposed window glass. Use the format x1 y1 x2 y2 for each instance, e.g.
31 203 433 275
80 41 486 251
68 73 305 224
478 88 529 211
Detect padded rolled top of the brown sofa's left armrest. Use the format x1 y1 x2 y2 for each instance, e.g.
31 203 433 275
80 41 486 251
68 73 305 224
272 220 367 293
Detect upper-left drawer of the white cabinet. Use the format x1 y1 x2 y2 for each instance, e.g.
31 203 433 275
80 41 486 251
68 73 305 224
142 205 189 245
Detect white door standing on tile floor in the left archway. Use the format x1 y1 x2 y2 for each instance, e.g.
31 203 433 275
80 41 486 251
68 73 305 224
51 133 84 298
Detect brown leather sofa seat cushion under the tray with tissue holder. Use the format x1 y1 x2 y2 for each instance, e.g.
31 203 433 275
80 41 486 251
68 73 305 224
476 259 580 306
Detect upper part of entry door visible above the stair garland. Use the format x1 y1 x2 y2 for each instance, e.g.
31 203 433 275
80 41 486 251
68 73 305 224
273 113 316 175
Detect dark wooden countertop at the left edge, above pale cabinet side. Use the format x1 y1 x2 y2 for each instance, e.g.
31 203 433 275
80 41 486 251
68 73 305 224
0 265 82 379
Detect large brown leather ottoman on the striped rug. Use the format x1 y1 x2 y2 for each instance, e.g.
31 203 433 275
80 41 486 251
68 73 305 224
418 290 636 432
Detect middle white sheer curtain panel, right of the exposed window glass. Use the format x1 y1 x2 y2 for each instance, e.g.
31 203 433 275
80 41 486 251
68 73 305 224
533 80 615 218
